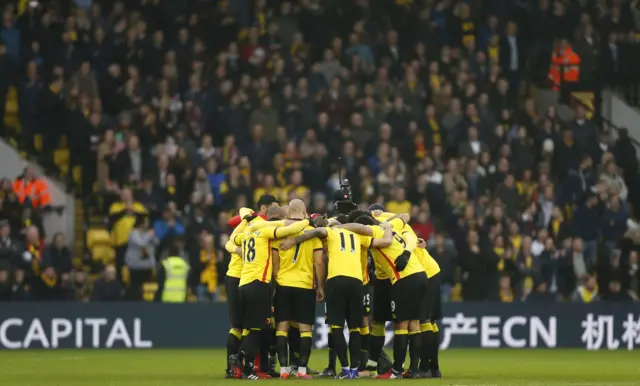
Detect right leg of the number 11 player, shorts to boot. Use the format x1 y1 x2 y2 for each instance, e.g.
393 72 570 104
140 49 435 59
345 279 364 378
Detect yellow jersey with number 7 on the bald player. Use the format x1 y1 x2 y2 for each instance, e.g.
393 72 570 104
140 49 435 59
273 222 323 289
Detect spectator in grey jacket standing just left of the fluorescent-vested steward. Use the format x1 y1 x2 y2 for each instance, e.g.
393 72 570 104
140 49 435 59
125 216 158 300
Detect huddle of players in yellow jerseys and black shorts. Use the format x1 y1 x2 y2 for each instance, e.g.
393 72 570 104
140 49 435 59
226 191 441 380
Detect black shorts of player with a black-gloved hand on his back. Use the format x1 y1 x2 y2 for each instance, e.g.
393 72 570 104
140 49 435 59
391 272 427 322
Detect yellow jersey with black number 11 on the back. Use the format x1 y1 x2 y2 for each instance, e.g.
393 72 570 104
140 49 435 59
325 228 370 281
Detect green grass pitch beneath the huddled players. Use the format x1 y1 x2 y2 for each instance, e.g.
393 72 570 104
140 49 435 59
0 349 640 386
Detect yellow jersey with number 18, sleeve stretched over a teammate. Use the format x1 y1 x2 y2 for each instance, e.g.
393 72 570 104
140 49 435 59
238 220 309 287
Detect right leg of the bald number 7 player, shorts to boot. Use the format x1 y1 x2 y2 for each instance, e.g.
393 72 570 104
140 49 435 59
293 289 316 378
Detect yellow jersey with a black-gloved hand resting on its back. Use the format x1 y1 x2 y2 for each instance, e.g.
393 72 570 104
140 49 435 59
370 219 424 284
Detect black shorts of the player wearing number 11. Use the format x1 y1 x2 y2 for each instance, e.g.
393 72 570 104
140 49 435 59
325 276 364 328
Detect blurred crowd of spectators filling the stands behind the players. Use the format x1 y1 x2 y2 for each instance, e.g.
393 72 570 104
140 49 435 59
0 0 640 302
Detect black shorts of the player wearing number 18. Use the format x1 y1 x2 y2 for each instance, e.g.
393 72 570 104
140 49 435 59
239 280 271 329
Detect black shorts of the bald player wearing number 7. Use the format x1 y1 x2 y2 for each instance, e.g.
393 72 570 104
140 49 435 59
275 285 316 325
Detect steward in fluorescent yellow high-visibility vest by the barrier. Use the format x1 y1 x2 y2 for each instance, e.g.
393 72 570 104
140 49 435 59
155 240 190 303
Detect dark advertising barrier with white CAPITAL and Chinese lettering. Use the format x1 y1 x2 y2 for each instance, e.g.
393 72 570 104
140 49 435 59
0 303 640 350
